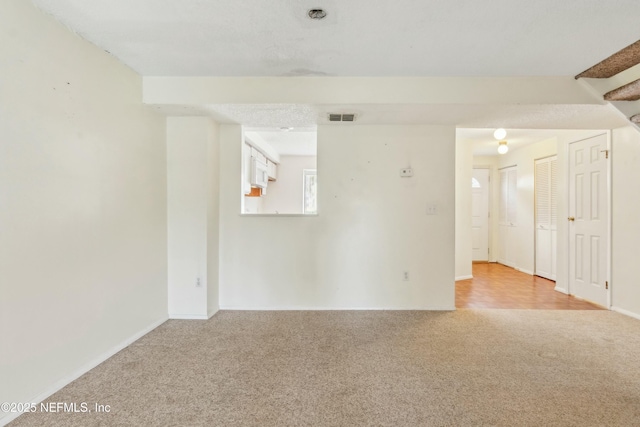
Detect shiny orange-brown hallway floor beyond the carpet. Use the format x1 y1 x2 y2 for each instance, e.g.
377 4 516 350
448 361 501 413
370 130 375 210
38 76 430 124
456 263 602 310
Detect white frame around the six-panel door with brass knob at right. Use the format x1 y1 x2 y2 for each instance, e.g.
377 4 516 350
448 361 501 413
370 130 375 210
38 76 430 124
558 130 613 310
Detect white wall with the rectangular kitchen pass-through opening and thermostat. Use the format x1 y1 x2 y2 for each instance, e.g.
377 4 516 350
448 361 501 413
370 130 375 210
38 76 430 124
220 125 455 309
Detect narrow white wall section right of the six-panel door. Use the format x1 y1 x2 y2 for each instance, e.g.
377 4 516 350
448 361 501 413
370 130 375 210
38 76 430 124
611 126 640 317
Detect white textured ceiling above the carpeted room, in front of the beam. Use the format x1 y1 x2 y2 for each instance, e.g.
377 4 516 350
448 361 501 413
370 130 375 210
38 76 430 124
34 0 640 76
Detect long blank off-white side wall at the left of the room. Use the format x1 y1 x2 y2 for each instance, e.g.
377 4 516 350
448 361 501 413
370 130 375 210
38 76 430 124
0 0 167 424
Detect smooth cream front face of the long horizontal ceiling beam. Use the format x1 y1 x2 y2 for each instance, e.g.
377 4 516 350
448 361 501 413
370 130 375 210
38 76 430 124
143 76 604 105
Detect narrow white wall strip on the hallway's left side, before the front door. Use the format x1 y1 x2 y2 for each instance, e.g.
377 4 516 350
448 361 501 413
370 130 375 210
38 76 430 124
456 139 473 280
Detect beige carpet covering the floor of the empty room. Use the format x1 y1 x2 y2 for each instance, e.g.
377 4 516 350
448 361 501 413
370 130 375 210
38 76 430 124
10 310 640 427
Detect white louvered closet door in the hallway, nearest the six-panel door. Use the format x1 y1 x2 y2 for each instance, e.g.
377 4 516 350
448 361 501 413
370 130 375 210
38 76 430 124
535 156 558 280
